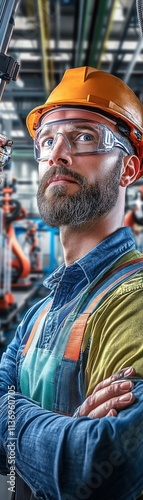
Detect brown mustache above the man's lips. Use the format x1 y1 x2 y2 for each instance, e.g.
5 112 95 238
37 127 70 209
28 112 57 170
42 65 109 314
39 165 87 189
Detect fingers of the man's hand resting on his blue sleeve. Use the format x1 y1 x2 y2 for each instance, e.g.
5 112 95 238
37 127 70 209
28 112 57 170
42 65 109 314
80 375 135 418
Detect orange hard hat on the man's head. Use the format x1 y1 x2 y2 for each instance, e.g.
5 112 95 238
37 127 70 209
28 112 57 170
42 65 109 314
26 66 143 177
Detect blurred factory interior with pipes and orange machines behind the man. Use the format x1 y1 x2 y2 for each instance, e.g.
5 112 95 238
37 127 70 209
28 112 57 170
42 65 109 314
0 0 143 353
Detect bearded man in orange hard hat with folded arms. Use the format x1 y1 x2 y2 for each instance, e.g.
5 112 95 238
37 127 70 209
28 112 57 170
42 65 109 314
0 67 143 500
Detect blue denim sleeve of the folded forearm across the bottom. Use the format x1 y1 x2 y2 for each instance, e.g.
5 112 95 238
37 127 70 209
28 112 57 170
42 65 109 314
0 381 143 500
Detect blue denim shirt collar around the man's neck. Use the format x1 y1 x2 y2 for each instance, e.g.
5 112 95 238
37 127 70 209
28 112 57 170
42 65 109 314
43 227 135 291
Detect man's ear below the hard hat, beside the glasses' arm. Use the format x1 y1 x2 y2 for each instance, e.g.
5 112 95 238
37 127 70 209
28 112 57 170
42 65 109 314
120 155 140 187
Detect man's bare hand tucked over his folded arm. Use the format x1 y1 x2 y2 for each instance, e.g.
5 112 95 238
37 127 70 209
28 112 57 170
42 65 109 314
74 366 136 418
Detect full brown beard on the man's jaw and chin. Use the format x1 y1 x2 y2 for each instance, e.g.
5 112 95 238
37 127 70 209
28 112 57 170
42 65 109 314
37 152 122 228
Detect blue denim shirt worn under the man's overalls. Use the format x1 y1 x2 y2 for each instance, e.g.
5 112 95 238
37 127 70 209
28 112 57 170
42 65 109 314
0 228 143 500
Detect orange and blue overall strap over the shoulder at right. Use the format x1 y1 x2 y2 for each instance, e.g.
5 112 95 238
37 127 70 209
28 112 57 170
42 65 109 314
64 258 143 361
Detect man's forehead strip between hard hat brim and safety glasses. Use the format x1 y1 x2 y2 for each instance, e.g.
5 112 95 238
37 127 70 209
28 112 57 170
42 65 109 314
41 107 116 126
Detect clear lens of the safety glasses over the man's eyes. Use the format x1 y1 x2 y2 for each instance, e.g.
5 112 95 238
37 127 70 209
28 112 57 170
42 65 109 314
34 119 128 162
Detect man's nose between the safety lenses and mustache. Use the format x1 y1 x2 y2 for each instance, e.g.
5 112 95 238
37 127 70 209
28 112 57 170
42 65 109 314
49 132 72 166
